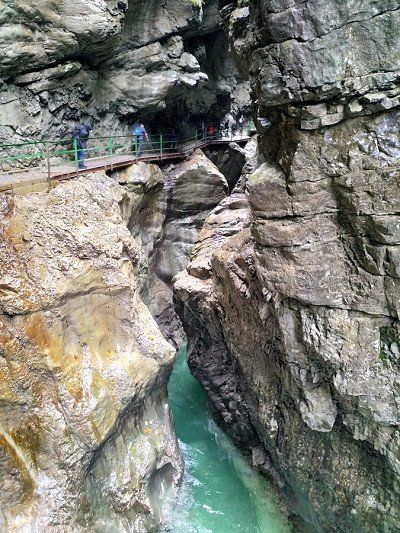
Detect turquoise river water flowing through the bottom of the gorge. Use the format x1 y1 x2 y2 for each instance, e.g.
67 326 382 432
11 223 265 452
167 351 291 533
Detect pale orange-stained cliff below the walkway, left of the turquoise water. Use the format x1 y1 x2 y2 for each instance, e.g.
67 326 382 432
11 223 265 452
0 174 181 532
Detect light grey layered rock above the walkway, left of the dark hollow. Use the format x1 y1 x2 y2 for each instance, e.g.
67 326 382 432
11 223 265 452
0 0 203 139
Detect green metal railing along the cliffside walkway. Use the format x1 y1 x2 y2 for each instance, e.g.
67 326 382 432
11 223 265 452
0 128 248 179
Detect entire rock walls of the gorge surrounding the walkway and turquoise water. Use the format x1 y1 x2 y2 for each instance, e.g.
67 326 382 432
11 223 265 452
0 0 400 533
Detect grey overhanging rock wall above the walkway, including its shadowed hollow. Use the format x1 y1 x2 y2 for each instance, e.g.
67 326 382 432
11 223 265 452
0 0 249 143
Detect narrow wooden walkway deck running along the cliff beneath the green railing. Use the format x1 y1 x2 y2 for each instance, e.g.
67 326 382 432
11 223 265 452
0 137 249 192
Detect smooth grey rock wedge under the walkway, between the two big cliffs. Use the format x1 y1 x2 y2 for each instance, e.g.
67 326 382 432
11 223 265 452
113 150 228 346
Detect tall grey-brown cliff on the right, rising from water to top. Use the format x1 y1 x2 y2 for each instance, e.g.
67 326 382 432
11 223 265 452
175 1 400 532
